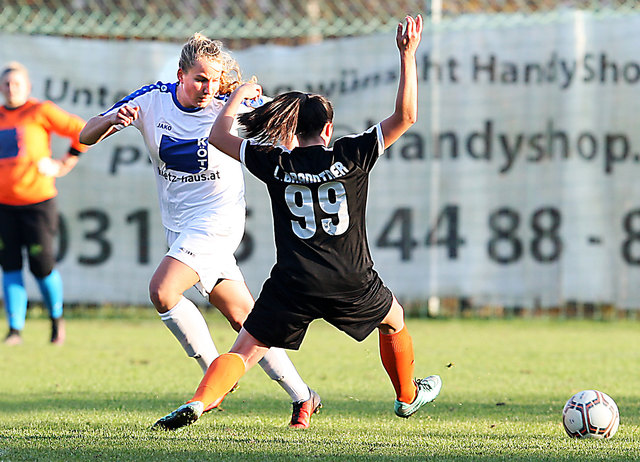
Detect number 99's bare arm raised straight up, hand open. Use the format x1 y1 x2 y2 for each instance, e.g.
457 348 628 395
380 15 422 147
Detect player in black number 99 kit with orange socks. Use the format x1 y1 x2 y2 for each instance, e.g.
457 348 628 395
153 16 442 430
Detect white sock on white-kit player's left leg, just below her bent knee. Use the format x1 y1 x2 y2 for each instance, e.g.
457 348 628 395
159 297 218 374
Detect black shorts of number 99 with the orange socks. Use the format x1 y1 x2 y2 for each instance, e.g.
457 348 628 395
244 273 393 350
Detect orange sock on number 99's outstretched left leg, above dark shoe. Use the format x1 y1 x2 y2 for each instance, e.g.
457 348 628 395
188 353 246 409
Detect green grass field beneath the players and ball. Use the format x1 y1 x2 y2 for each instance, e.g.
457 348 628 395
0 308 640 461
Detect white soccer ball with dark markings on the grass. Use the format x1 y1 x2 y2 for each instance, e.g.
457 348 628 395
562 390 620 438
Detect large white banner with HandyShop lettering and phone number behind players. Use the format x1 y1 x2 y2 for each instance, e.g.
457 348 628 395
0 12 640 308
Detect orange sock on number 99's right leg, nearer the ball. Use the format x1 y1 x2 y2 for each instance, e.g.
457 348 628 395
379 326 417 403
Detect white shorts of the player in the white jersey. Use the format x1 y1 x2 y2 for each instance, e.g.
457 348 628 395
165 224 244 297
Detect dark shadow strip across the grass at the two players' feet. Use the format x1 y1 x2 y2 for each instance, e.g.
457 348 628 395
0 389 640 425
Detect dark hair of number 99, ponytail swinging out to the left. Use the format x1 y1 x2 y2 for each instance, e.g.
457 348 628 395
238 91 333 144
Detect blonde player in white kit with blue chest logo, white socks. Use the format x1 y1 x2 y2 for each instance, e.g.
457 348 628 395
80 34 321 428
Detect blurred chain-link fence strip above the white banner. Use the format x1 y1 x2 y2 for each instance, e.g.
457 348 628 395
0 0 638 43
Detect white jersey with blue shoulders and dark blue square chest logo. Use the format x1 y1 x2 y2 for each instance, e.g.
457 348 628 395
102 82 246 232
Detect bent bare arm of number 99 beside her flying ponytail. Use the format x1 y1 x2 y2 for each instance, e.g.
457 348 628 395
209 83 262 161
